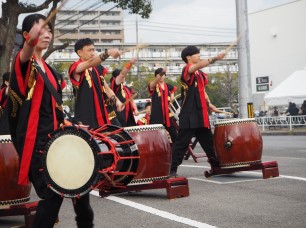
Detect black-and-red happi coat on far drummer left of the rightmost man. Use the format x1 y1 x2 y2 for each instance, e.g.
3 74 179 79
148 83 176 127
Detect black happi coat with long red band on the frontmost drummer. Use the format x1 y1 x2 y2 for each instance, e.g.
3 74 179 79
7 52 65 189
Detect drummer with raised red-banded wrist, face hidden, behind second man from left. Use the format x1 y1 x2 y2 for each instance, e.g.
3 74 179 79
110 58 139 127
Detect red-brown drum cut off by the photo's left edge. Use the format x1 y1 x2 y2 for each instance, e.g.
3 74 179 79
0 135 31 207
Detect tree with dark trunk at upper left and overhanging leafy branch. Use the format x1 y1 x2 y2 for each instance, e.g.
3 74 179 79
0 0 152 81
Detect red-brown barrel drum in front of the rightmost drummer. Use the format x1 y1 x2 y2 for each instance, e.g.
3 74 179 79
214 119 262 168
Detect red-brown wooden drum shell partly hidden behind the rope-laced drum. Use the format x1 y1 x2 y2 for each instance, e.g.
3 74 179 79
129 129 172 180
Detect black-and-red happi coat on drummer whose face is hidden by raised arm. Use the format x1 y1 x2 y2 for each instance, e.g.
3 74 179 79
110 77 136 127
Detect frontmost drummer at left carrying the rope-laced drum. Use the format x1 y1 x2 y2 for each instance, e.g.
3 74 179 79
7 14 93 228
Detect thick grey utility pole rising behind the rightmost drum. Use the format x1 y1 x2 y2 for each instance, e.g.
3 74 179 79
236 0 253 118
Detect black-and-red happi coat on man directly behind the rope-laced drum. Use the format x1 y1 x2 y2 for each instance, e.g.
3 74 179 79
69 60 110 128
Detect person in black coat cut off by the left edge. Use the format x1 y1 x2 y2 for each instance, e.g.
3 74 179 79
0 72 11 135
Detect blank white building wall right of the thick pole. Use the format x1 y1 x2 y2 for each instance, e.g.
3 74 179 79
248 0 306 109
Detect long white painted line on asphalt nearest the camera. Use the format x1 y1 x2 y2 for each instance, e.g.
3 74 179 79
90 191 215 228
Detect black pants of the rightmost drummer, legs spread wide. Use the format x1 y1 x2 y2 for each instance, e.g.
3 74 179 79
171 128 216 172
